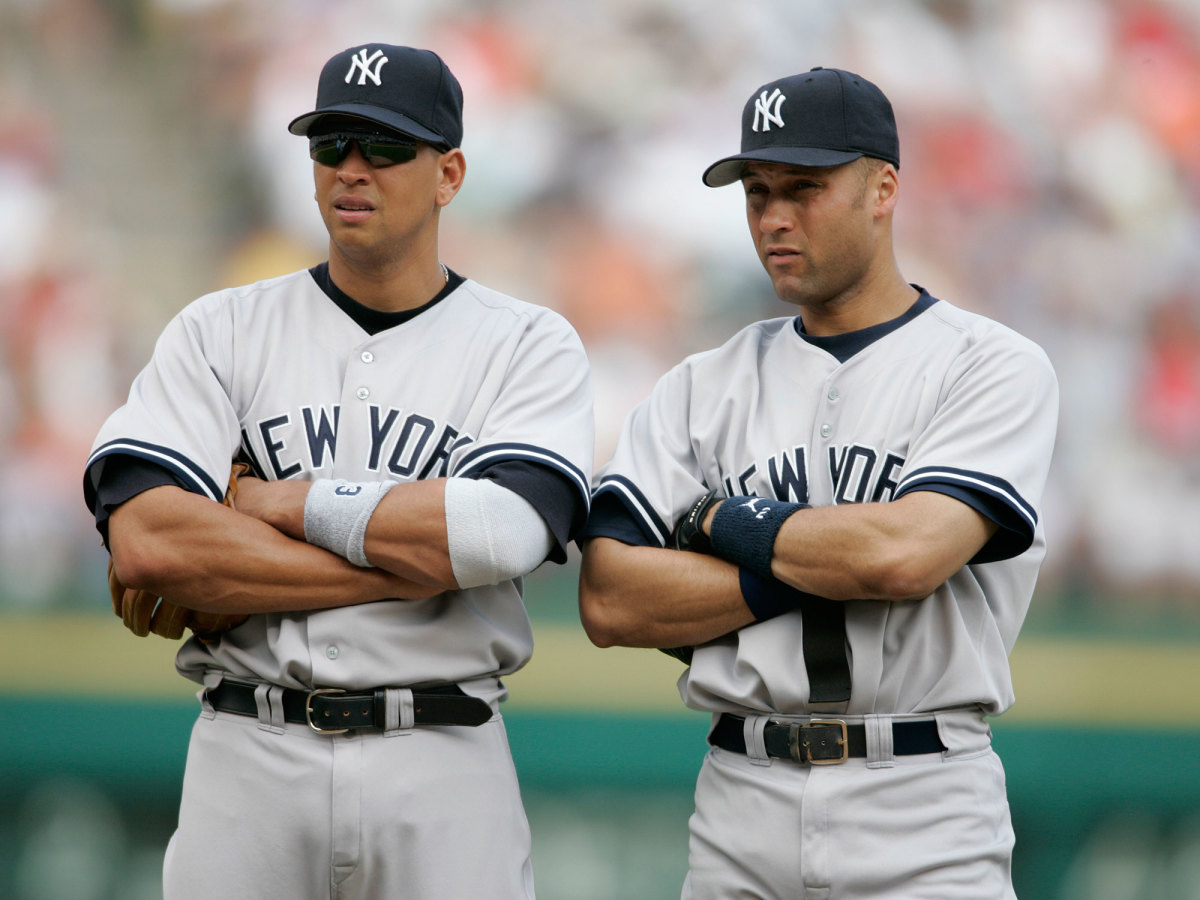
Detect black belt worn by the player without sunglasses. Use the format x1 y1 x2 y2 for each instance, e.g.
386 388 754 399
708 713 946 766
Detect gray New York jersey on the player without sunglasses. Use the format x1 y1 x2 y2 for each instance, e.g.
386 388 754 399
587 292 1057 715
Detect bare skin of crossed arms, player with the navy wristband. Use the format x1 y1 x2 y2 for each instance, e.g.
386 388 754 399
580 491 997 647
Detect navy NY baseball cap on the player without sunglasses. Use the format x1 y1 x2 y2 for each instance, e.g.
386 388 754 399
704 66 900 187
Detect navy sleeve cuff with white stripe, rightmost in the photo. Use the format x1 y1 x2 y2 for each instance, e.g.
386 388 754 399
895 467 1038 563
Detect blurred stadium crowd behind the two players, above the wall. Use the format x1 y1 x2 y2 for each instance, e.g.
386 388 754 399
0 0 1200 629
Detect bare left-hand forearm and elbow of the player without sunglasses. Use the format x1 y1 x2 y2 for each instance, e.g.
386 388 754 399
580 538 755 647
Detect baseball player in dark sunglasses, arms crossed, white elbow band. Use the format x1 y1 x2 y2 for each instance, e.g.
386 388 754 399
85 43 593 900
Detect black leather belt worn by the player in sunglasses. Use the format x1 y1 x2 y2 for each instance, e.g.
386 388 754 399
204 679 492 734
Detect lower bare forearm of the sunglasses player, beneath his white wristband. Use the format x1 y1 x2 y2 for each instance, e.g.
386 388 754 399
109 487 438 613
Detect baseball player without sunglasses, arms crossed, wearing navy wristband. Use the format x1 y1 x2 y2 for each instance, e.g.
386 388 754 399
580 68 1057 900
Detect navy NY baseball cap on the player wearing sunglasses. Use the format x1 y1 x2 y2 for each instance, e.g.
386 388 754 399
288 43 462 150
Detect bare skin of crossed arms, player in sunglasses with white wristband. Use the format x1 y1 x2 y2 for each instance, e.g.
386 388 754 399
108 478 458 613
